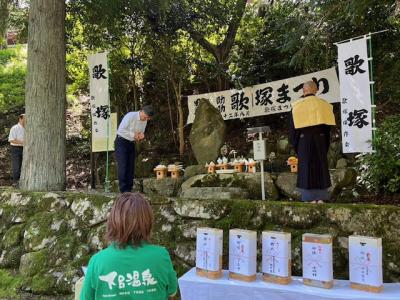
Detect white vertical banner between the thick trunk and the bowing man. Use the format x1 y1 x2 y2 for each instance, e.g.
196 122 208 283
88 52 116 152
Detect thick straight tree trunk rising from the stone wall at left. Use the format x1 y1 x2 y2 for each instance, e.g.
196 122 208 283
21 0 66 191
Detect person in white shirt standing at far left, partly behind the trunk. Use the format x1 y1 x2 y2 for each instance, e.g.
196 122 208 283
8 114 25 185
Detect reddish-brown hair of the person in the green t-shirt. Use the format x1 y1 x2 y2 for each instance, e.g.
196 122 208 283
106 193 154 248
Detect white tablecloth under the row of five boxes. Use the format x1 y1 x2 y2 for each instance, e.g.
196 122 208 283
179 268 400 300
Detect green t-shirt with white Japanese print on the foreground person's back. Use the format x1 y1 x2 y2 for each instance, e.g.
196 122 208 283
80 243 177 300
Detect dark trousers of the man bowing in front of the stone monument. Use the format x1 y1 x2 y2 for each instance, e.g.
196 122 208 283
115 135 135 193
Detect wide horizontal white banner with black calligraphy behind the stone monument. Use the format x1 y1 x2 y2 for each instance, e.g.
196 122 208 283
187 68 339 124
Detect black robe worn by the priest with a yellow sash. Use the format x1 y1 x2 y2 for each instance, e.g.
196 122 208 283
290 114 331 190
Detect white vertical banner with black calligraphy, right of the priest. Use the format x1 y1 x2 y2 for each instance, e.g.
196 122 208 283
337 37 373 153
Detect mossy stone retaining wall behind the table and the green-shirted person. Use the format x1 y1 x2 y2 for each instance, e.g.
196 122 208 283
0 190 400 299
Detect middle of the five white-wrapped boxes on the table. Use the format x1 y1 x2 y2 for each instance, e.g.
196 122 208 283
262 231 292 284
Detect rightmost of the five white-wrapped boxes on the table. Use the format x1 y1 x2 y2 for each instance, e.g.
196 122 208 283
349 235 383 293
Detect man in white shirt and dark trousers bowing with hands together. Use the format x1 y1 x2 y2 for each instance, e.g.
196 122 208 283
115 105 154 193
